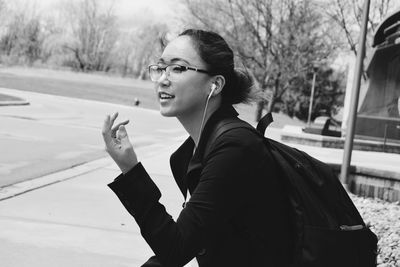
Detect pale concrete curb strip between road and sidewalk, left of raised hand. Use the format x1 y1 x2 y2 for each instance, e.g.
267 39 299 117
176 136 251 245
0 158 111 201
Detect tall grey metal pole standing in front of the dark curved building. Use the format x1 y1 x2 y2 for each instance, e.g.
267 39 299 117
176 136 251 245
340 0 370 189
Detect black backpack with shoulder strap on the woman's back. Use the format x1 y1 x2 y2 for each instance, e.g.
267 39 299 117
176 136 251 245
204 113 378 267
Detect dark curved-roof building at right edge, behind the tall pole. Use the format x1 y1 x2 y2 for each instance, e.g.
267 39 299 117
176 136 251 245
342 10 400 143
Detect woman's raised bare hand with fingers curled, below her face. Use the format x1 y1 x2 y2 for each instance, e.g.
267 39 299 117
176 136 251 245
102 112 138 174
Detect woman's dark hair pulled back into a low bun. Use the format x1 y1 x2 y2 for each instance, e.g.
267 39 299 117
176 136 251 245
179 29 255 105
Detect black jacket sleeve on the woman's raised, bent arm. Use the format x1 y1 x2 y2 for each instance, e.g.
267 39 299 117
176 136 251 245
109 130 255 266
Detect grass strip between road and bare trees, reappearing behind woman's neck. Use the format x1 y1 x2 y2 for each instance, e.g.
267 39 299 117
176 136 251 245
0 67 305 128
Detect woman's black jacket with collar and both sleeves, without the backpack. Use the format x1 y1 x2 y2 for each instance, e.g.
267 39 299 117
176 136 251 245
109 107 293 267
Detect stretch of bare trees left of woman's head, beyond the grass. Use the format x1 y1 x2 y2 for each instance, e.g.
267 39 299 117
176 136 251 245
0 0 168 79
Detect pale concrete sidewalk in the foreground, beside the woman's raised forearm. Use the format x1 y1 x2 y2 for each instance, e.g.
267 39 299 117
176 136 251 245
0 141 183 267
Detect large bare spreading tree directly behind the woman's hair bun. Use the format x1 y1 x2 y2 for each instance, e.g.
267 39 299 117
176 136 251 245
186 0 334 120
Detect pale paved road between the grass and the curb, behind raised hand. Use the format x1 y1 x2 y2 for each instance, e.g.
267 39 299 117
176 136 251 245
0 88 185 187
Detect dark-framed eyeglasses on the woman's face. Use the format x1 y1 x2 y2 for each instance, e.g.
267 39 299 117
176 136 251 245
149 64 210 82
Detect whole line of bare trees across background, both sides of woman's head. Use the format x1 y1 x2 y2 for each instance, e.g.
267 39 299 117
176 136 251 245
0 0 398 120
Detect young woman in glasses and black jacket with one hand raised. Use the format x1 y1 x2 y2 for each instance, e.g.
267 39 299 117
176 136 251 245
103 29 293 267
